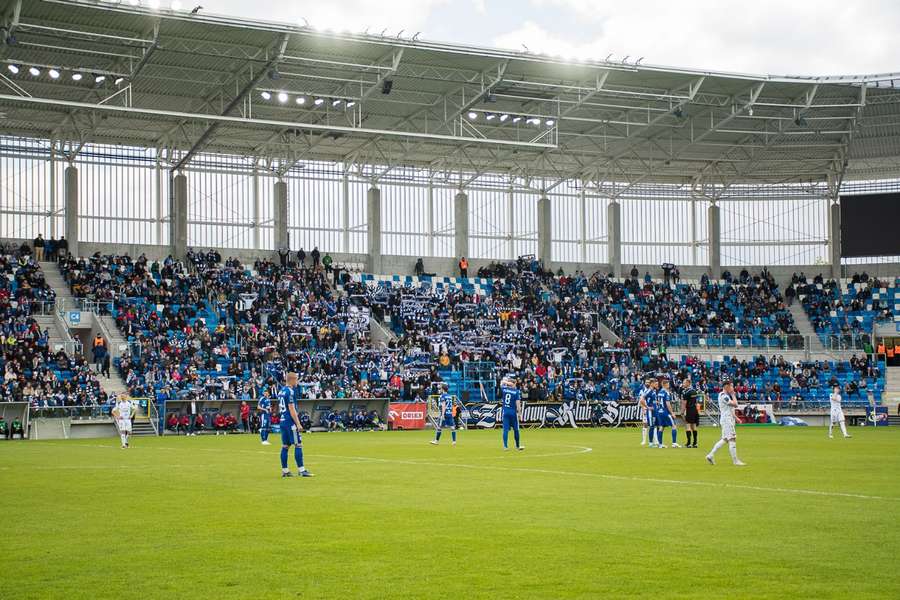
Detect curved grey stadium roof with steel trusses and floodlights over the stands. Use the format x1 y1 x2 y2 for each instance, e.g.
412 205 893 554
0 0 900 188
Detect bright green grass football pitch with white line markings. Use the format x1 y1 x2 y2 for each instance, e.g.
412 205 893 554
0 428 900 600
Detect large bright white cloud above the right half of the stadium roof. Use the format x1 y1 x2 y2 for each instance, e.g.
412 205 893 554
493 0 900 75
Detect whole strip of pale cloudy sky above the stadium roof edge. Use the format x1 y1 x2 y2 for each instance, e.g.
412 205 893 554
186 0 900 75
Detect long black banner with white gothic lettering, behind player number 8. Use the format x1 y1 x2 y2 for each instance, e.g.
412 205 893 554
466 401 641 429
